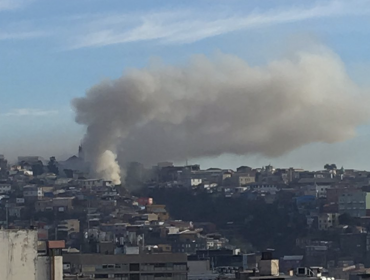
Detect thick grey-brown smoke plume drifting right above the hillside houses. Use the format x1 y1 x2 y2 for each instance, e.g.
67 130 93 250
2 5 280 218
73 50 368 183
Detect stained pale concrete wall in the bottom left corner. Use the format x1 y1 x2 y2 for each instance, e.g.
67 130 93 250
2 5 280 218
0 230 38 280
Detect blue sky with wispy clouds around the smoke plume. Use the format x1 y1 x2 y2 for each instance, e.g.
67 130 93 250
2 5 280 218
0 0 370 169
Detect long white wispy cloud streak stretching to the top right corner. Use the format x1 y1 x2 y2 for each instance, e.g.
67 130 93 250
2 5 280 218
69 1 370 49
